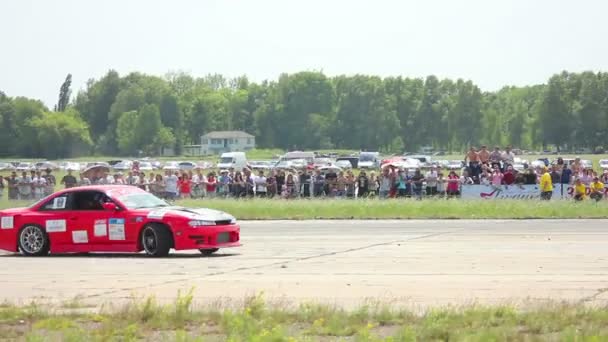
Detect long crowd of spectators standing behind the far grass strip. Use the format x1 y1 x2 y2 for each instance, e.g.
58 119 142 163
0 146 608 200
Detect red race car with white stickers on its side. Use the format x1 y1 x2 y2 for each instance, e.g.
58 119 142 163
0 185 240 256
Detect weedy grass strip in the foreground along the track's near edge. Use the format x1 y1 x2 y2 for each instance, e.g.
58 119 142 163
0 292 608 341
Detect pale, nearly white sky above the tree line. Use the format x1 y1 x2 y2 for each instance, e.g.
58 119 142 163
0 0 608 106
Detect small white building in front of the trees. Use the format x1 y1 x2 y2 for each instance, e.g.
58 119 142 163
201 131 255 155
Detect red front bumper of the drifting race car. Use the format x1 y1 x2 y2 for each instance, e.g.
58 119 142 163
174 224 241 250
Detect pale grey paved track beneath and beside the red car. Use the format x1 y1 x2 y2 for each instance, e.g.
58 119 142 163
0 220 608 307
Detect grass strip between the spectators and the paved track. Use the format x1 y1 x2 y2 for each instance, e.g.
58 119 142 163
0 199 608 220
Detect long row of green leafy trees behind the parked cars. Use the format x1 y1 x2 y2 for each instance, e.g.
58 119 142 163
0 70 608 158
